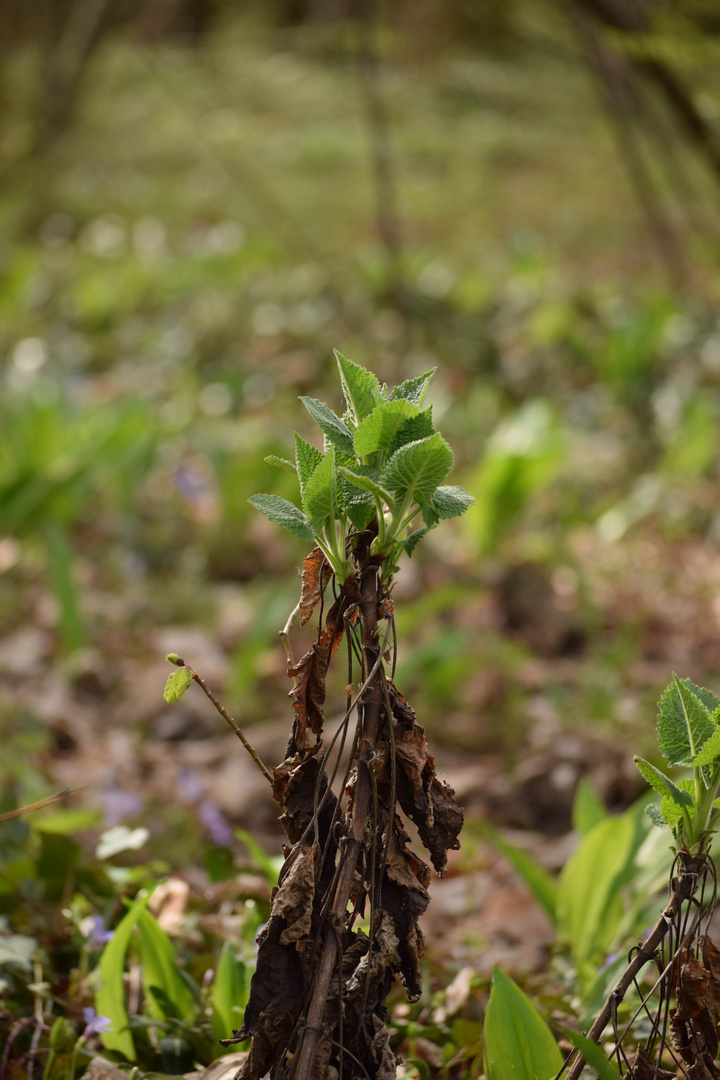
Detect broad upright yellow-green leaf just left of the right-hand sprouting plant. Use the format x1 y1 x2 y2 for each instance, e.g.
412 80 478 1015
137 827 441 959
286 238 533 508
557 807 644 964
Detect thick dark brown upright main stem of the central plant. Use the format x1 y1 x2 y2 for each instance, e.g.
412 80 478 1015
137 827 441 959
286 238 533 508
294 548 383 1080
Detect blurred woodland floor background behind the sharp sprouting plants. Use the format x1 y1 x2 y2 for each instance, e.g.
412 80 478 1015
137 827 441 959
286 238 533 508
0 0 720 1032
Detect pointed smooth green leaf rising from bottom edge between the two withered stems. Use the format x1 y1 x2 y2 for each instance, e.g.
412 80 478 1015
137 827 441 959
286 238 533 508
484 966 562 1080
